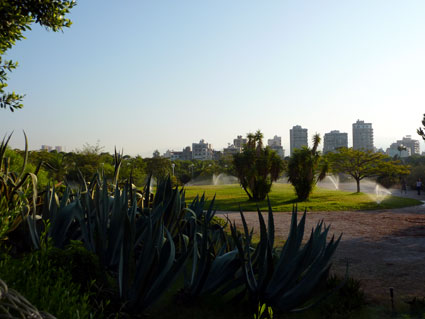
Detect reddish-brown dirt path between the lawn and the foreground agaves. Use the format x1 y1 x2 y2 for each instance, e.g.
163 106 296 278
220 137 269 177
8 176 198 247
220 206 425 299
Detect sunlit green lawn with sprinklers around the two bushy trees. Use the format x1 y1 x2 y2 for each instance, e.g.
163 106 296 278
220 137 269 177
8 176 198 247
185 183 422 212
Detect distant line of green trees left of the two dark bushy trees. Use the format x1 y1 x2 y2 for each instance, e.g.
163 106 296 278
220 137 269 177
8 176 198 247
7 140 233 187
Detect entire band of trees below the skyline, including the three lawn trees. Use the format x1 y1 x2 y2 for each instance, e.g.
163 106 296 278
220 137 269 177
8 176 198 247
7 131 410 201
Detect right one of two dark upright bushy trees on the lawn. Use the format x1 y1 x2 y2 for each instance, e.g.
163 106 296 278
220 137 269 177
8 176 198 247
288 134 328 201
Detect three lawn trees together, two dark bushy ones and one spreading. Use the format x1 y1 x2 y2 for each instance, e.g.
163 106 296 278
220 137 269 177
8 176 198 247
233 131 410 201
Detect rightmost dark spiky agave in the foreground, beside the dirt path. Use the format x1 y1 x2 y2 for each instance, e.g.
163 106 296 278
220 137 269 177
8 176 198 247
231 202 342 311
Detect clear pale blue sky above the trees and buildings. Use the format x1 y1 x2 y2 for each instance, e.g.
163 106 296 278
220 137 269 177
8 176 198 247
0 0 425 156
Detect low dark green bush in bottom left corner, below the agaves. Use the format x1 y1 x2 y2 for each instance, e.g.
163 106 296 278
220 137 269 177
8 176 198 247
0 245 101 319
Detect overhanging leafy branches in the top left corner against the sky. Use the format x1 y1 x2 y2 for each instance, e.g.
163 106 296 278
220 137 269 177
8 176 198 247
0 0 75 112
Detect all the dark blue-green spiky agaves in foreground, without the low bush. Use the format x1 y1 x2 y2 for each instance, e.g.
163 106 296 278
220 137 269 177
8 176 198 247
15 170 338 315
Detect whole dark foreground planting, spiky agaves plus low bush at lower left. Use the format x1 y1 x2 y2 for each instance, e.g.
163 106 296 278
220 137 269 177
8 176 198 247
0 148 338 318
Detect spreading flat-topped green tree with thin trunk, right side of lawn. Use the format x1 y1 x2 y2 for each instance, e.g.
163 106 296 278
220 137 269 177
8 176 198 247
327 148 410 193
